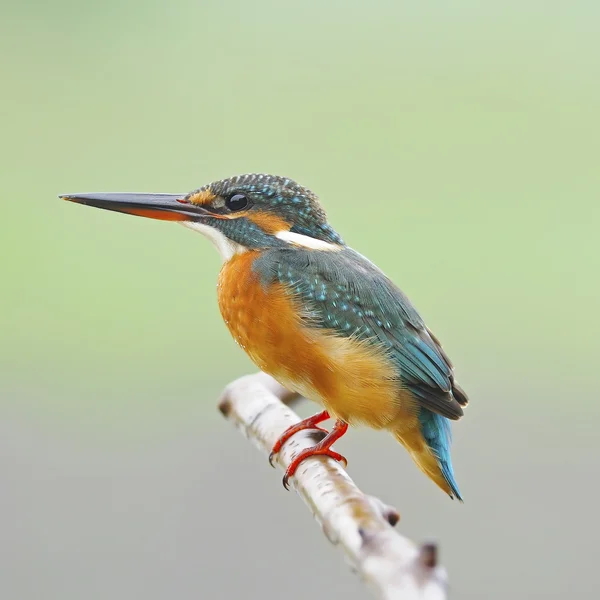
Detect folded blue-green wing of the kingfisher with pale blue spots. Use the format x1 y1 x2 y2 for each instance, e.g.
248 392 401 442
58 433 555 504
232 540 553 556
254 247 468 419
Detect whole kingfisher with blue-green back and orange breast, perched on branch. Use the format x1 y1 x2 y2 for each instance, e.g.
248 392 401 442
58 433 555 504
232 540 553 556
61 174 468 501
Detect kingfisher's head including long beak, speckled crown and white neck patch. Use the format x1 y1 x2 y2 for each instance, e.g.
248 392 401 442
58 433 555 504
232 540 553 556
61 174 343 260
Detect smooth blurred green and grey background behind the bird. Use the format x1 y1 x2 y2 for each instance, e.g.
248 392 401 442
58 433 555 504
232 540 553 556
0 0 600 600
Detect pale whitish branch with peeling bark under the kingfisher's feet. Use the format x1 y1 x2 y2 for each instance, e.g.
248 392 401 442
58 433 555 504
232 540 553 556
219 373 447 600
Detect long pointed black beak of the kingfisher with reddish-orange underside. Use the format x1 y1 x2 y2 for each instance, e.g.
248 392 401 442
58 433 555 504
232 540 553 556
60 193 208 221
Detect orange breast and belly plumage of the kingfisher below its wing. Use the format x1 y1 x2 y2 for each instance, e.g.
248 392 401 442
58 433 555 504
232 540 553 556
218 251 417 429
